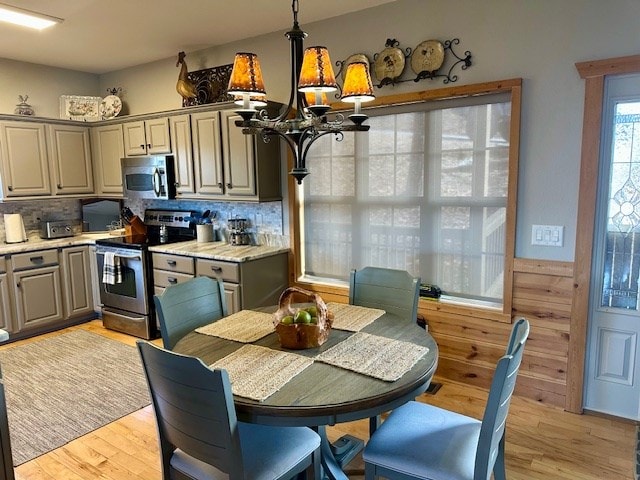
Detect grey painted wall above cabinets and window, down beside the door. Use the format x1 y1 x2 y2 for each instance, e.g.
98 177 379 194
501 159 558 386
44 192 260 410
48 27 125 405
5 0 640 261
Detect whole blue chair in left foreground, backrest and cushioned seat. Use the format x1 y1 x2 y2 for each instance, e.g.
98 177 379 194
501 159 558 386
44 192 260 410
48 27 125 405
137 341 320 480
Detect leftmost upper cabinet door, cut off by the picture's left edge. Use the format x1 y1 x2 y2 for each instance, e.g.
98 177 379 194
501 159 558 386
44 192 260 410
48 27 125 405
0 122 51 197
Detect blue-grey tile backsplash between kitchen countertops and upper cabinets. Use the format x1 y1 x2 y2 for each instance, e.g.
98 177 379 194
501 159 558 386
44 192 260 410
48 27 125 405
0 198 289 245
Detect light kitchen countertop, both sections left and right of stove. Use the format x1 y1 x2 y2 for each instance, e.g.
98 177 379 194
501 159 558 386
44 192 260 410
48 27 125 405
0 232 289 262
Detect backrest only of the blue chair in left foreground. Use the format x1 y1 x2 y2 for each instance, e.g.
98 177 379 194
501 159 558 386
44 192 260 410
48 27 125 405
137 341 242 478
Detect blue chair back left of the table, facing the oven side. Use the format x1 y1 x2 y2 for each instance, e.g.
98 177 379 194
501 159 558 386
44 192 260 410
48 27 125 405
153 277 227 350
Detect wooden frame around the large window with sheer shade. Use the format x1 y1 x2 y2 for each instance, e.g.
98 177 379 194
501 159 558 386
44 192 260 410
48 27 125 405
288 78 522 323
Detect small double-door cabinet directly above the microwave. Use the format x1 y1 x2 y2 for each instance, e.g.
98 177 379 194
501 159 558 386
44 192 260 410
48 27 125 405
122 117 171 156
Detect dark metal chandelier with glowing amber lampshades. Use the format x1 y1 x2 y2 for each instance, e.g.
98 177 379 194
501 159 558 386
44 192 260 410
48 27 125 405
227 0 375 184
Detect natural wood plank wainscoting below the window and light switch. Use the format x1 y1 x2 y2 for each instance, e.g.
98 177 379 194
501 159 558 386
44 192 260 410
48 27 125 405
299 258 573 408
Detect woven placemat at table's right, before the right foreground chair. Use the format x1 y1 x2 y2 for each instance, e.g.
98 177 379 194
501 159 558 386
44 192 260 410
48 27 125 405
315 332 429 382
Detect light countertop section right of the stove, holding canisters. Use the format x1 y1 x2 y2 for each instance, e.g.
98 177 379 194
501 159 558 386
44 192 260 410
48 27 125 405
149 240 289 262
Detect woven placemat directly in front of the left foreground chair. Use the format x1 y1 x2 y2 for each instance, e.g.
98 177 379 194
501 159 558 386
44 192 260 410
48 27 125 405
211 345 313 402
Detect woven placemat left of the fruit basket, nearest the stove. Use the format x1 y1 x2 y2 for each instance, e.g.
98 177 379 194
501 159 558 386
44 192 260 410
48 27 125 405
196 310 275 343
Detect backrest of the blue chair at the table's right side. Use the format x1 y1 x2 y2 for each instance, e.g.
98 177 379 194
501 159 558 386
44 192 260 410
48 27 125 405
474 318 529 480
